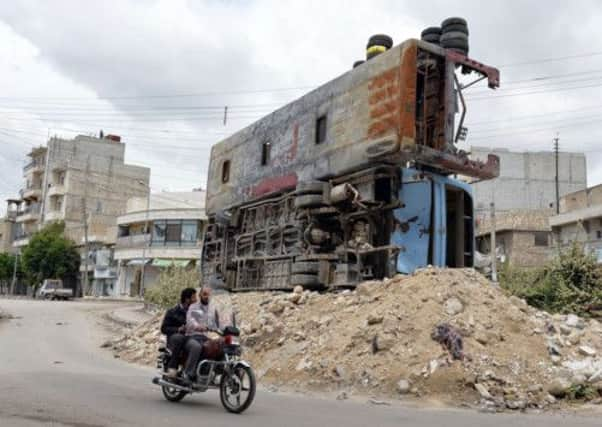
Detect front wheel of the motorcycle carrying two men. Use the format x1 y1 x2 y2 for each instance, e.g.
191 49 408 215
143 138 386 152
219 366 256 414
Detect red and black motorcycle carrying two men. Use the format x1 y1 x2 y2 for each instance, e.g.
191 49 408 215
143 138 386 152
153 300 256 414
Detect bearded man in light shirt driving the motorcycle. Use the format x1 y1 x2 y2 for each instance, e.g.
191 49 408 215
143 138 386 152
184 286 218 381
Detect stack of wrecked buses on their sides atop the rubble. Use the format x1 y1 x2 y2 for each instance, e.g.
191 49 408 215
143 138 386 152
202 33 499 290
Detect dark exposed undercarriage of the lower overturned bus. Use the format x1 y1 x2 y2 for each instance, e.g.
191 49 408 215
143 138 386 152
202 164 400 290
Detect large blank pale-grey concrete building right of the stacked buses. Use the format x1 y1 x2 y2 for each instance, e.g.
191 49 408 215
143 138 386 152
471 147 587 218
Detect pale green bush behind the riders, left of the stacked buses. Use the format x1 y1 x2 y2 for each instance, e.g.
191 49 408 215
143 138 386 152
144 266 201 308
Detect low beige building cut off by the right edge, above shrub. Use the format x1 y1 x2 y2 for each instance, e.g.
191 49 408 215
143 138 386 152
550 184 602 262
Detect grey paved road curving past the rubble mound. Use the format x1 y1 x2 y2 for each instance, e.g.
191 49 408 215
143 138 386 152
0 300 600 427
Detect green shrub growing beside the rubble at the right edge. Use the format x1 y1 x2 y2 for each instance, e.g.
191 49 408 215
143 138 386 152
500 244 602 316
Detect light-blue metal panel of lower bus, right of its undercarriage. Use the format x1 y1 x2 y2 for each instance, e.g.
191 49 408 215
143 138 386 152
391 169 432 274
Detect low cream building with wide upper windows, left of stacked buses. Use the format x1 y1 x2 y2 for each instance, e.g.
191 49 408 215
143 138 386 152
113 191 206 298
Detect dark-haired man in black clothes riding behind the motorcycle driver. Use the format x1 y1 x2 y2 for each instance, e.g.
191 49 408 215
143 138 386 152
161 288 197 378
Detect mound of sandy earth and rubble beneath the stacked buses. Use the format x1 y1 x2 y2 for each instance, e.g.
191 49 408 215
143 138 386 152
108 268 602 411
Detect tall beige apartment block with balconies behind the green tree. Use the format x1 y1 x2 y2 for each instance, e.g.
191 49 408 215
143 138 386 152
7 135 150 290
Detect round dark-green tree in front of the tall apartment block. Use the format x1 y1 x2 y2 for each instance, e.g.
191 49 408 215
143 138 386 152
22 222 80 288
